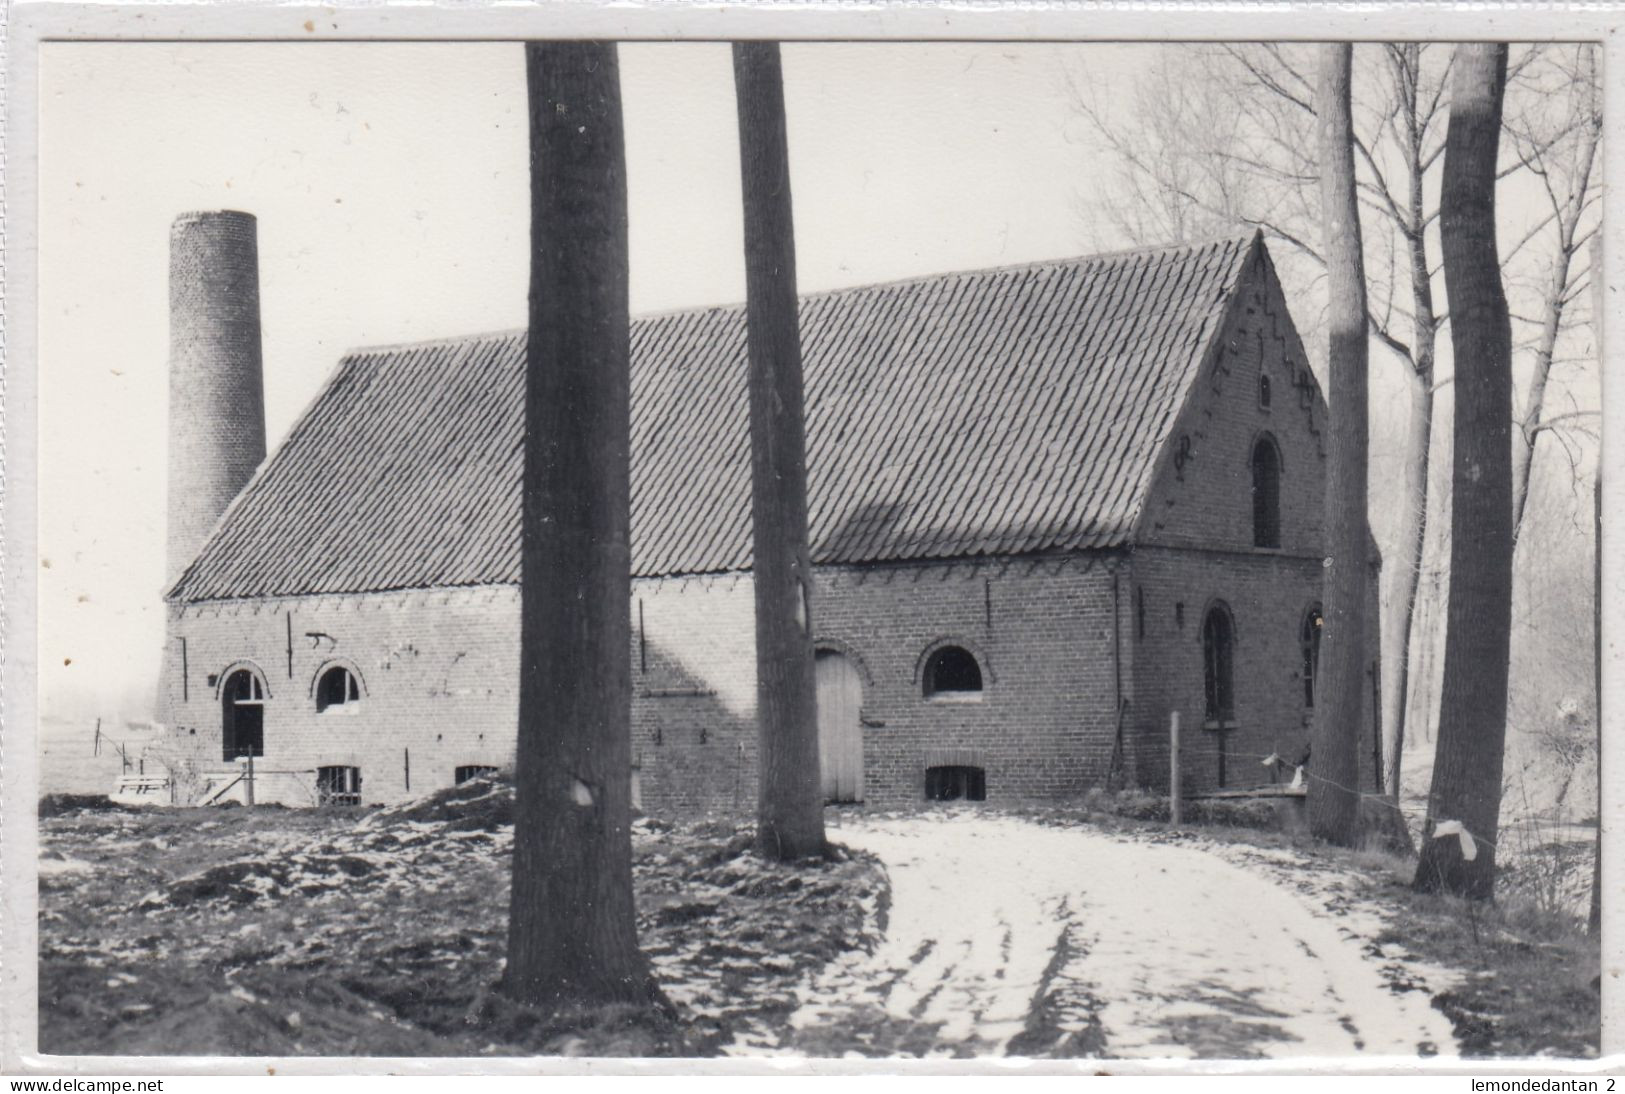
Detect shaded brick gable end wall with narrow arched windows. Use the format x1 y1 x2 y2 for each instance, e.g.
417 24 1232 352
1133 247 1381 788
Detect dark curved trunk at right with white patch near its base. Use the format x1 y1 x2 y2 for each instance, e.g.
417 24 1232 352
1414 44 1513 899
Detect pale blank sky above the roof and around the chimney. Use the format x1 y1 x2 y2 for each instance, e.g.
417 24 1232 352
39 44 1155 718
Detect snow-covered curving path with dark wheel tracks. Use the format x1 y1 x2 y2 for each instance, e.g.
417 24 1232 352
760 813 1454 1057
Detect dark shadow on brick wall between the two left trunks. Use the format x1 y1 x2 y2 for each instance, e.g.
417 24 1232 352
632 630 757 816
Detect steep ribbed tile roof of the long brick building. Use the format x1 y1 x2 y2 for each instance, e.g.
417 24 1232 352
171 239 1261 601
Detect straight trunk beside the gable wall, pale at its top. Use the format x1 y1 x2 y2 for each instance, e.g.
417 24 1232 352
1308 42 1370 847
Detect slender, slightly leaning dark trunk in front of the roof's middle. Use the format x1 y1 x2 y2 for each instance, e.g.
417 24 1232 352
733 42 824 860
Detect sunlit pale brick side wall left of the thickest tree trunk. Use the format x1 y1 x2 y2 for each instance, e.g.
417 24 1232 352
159 587 518 805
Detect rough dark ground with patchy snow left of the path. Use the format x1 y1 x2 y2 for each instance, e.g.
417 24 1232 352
39 782 886 1057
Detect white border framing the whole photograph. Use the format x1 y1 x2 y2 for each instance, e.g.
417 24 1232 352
0 0 1625 1076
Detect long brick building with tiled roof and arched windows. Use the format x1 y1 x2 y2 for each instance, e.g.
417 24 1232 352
159 230 1378 810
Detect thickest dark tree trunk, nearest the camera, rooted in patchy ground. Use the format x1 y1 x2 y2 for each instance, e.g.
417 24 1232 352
502 42 658 1008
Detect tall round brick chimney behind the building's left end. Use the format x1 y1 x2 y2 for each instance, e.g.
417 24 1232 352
166 210 265 580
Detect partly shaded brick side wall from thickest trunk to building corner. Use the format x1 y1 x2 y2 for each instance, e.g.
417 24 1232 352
632 556 1126 810
